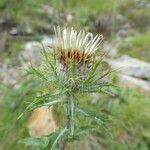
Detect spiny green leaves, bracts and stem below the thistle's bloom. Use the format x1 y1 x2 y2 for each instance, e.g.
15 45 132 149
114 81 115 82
20 44 114 150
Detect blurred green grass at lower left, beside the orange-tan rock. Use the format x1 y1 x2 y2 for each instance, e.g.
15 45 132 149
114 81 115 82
0 78 38 150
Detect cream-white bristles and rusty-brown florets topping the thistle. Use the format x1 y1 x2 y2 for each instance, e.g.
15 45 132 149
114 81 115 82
52 27 103 74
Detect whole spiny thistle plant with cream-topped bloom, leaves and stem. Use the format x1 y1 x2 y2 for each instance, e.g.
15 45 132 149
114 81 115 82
19 27 116 150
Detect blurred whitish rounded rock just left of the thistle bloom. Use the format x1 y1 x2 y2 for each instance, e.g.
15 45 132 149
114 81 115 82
20 41 42 67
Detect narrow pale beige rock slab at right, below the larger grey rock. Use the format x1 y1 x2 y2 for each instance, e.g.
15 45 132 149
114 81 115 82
119 74 150 94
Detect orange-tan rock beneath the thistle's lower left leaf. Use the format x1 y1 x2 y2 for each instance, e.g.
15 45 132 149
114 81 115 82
27 106 58 137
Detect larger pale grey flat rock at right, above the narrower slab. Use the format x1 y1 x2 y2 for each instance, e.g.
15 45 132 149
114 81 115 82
107 55 150 80
